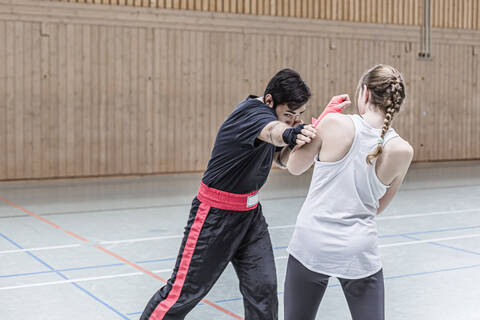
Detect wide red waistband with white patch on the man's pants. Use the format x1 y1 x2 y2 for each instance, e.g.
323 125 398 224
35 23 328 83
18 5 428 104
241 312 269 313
197 182 258 211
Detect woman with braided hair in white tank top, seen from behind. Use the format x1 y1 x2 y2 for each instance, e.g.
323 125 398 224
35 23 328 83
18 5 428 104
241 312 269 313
284 65 413 320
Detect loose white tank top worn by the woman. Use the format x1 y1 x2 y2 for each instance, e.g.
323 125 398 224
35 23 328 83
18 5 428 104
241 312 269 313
287 115 398 279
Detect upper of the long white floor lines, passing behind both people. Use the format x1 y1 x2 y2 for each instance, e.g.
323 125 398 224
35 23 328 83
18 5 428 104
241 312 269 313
0 208 480 254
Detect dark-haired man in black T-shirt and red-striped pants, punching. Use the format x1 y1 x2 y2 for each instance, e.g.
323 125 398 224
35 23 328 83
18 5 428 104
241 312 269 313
141 69 315 320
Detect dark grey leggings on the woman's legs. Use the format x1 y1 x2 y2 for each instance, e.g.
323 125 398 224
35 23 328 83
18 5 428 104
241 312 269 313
284 256 385 320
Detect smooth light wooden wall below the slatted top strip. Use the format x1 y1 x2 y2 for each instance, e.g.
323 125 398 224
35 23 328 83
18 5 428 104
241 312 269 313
0 0 480 180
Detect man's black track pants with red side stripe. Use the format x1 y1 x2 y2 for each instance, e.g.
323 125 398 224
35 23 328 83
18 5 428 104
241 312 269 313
140 198 278 320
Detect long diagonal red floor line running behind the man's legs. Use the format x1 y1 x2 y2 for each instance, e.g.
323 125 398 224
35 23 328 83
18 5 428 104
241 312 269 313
0 197 244 320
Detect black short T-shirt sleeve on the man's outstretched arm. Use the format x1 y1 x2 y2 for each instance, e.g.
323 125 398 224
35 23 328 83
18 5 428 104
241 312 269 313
234 103 278 146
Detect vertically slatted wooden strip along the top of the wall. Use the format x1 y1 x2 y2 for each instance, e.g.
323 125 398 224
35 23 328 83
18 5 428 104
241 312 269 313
37 0 480 30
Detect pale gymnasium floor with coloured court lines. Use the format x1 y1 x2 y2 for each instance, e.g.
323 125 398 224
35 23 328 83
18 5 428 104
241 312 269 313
0 162 480 320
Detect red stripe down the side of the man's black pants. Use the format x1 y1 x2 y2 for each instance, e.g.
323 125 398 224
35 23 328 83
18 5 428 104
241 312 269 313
149 202 210 320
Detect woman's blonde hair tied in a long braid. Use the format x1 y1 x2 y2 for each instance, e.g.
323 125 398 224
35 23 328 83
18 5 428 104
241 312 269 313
357 64 405 165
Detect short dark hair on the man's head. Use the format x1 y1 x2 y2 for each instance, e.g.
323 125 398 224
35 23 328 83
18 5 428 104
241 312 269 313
263 69 312 110
